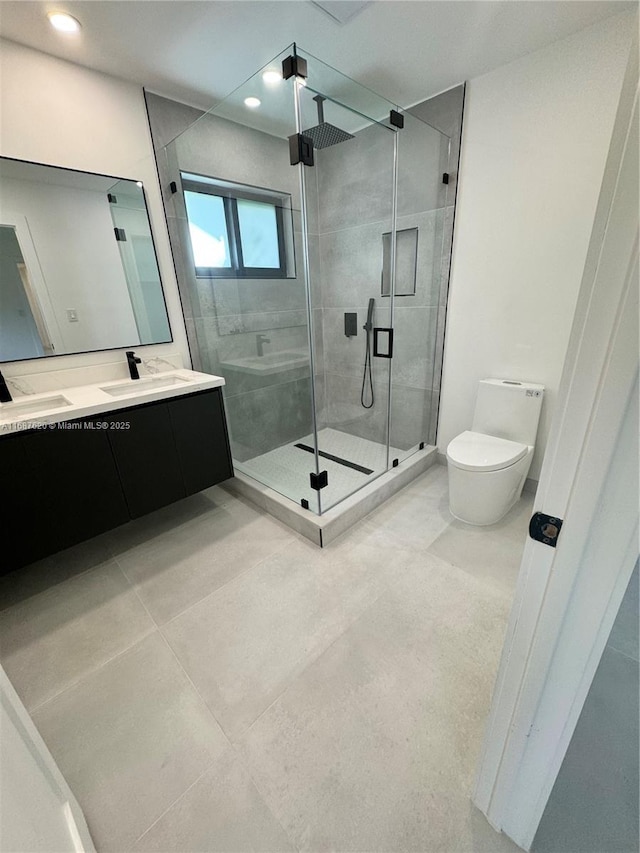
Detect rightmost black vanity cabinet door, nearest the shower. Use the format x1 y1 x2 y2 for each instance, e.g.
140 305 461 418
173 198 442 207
169 388 233 495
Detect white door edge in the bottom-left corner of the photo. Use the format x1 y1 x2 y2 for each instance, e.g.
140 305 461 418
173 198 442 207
0 667 95 853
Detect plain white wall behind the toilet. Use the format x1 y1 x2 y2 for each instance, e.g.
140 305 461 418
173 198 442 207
438 13 635 479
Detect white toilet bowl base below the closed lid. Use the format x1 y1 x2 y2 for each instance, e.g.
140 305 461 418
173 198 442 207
447 448 533 527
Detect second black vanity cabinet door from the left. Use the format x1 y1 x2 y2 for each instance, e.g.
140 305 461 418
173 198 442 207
24 418 129 554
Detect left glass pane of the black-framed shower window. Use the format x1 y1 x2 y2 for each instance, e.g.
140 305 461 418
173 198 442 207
184 190 231 269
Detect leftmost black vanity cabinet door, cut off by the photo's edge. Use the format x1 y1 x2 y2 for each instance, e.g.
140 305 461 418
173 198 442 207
0 435 54 574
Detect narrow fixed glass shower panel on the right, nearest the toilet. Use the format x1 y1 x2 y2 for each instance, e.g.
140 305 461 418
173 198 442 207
383 113 453 464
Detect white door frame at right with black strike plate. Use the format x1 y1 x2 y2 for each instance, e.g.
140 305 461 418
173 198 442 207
474 26 638 850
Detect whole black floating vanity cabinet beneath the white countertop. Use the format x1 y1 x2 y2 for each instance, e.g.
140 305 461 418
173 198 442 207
0 388 233 572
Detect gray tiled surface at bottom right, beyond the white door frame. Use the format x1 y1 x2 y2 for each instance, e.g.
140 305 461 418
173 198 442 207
532 564 640 853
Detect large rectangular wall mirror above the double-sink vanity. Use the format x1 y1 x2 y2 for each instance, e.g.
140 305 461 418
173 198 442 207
0 157 172 362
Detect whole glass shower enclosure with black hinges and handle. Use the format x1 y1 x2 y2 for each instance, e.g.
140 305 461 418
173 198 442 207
164 45 453 514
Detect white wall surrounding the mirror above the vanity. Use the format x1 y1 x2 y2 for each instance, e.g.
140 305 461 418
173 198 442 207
0 41 190 376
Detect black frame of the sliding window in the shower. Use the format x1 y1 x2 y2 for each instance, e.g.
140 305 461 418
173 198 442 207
181 174 289 279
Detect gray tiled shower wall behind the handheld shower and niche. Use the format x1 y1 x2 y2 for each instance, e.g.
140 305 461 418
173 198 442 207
312 86 464 450
